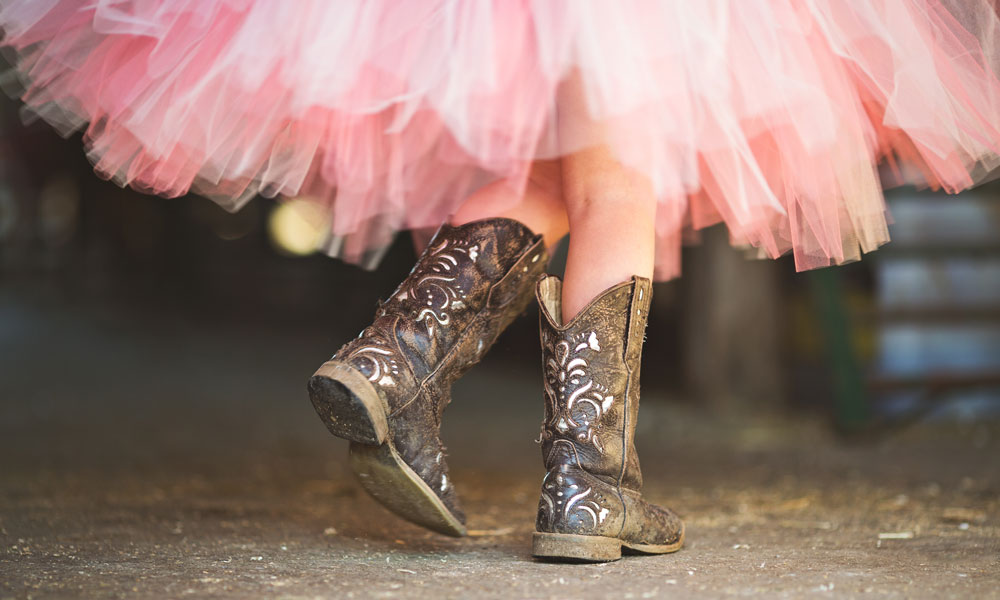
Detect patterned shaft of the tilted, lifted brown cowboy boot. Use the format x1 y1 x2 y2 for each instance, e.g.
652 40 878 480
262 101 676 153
334 218 546 412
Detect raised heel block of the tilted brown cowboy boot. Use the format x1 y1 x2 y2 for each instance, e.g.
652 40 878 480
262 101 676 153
309 361 389 446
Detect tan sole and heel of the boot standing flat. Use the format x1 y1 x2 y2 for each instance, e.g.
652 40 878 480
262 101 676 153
531 528 684 562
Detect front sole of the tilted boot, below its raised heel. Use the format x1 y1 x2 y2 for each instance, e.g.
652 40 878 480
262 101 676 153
350 440 468 537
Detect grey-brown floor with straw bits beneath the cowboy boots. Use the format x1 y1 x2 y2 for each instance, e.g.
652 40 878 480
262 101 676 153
0 294 1000 598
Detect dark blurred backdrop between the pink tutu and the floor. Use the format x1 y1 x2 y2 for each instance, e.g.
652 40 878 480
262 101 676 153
0 92 1000 431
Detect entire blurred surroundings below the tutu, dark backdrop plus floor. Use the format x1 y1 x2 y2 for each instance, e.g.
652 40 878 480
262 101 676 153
0 96 1000 598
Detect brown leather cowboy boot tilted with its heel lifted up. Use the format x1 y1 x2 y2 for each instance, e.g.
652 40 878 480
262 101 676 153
309 218 547 536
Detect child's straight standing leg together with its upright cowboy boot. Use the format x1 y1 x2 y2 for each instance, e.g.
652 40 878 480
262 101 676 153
531 74 684 562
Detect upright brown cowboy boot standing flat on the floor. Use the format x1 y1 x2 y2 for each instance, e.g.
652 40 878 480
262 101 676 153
532 276 684 562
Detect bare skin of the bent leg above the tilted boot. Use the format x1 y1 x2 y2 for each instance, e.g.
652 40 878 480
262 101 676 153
451 161 569 248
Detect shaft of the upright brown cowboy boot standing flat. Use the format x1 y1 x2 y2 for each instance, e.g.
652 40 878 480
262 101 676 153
536 277 652 491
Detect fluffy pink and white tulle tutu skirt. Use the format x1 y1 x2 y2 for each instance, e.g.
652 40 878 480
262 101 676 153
0 0 1000 279
